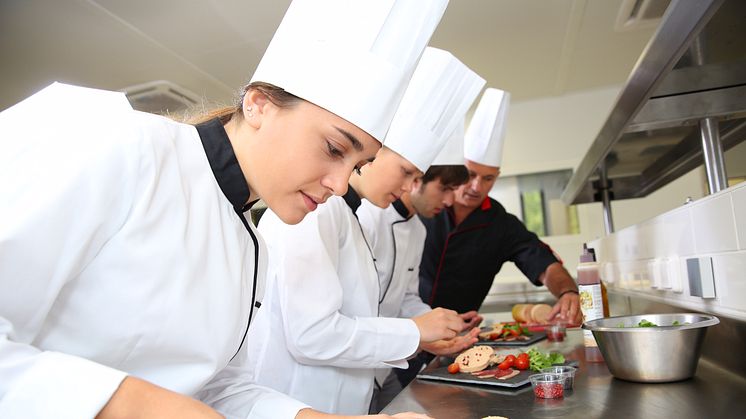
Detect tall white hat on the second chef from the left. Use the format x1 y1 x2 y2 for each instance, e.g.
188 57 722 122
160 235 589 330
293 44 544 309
383 47 485 172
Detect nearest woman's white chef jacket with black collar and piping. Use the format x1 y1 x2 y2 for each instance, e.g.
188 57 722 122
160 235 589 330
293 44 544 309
0 84 306 419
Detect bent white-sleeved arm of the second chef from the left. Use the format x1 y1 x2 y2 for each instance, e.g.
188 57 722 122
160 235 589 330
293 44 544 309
268 200 419 368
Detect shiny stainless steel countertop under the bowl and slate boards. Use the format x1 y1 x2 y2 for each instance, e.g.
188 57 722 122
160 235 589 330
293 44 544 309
382 329 746 419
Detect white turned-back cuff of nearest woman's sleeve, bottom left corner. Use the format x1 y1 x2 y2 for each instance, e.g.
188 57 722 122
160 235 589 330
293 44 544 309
0 352 127 419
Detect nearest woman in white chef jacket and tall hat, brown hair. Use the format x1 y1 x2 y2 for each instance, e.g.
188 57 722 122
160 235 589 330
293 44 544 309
0 0 446 419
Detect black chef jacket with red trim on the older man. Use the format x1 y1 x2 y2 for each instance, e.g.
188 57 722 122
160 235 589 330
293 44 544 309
420 197 558 313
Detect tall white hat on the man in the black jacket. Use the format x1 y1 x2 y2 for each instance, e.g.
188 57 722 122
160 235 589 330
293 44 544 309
464 88 510 167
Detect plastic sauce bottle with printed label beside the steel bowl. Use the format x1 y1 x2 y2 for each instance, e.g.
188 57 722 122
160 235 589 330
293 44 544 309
577 244 605 362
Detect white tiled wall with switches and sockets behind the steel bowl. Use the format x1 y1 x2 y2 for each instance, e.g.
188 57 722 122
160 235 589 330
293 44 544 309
592 183 746 320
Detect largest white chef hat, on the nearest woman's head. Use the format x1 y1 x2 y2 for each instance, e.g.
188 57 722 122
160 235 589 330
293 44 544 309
251 0 448 141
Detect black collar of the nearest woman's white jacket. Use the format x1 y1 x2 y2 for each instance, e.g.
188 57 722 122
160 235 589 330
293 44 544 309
196 118 256 212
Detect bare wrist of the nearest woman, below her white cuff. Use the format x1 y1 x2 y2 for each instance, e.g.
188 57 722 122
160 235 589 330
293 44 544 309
96 377 223 419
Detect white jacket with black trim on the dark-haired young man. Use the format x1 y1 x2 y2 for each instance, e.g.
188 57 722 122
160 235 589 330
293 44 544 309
357 199 431 318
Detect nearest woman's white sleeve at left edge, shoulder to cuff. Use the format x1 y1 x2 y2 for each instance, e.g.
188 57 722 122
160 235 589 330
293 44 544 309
0 84 137 418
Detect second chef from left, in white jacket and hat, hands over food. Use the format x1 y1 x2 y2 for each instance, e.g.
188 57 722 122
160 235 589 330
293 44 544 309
249 48 478 414
